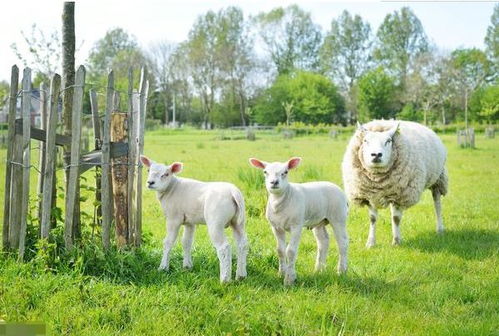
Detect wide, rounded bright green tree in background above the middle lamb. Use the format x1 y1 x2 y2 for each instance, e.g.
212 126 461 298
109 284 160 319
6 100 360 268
254 71 345 125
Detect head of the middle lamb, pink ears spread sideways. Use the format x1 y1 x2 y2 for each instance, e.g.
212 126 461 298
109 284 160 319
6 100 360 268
249 157 301 194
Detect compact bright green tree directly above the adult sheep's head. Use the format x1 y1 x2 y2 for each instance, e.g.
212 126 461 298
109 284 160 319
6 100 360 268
358 67 395 121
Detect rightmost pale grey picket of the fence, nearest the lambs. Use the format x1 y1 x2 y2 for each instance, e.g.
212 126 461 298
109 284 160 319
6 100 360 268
134 67 149 246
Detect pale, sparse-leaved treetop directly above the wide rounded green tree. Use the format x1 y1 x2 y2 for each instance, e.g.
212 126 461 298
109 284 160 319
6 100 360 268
255 5 322 75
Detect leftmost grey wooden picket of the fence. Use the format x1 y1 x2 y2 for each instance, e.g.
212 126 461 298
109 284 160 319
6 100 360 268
2 65 19 251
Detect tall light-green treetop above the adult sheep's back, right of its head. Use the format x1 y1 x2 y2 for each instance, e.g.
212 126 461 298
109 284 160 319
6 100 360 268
373 7 428 87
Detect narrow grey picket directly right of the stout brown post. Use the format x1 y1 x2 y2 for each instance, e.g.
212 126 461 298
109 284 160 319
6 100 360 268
127 68 137 243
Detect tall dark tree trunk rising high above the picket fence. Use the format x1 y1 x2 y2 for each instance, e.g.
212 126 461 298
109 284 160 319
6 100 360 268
62 1 81 237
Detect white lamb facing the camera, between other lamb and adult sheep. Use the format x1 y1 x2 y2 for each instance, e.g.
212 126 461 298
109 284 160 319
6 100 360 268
249 158 348 285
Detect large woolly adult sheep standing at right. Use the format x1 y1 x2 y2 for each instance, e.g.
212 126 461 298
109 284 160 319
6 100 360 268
342 120 448 248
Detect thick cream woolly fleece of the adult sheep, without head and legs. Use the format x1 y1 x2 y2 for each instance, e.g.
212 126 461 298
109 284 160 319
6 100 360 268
342 120 448 209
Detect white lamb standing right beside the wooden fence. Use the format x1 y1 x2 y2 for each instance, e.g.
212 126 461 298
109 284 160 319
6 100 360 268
140 156 248 282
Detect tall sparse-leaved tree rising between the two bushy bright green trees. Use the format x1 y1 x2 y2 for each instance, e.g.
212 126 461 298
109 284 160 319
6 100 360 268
320 10 372 120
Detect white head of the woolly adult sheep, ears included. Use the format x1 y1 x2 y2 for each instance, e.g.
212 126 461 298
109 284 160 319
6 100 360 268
357 123 399 170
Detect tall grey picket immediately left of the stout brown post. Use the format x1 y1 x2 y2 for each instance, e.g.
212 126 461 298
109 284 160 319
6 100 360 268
101 70 114 249
